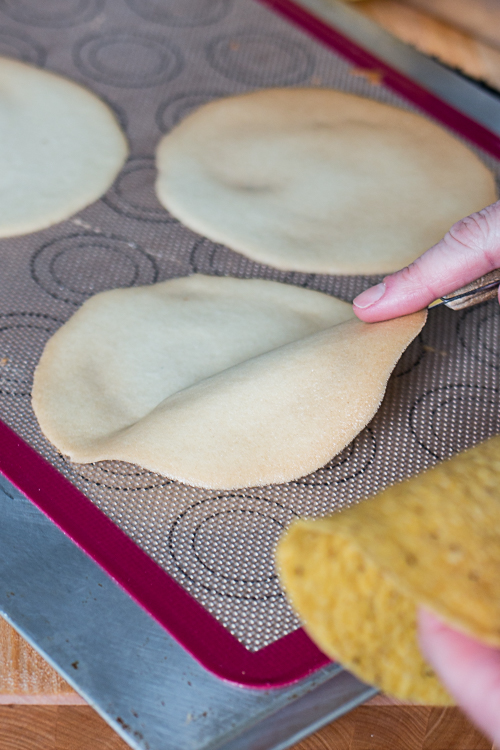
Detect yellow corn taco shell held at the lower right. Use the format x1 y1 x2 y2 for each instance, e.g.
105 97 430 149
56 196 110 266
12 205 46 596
277 437 500 704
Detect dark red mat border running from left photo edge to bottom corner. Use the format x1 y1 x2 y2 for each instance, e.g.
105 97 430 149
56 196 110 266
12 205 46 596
0 422 329 688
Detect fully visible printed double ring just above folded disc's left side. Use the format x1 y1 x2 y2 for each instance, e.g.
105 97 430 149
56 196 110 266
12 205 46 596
30 232 158 307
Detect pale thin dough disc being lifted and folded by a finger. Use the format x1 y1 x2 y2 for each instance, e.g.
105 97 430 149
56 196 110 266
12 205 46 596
33 275 425 489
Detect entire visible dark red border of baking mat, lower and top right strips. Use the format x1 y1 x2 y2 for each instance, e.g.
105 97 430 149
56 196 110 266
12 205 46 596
0 0 500 688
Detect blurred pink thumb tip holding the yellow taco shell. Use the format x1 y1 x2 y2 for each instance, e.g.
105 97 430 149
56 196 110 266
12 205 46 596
419 609 500 746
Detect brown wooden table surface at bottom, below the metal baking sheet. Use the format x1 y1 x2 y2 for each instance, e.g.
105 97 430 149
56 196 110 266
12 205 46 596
0 618 492 750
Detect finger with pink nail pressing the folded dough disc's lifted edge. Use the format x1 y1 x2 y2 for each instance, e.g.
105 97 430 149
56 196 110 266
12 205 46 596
353 201 500 323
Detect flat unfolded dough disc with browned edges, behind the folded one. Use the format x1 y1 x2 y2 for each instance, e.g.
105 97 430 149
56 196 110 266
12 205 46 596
156 89 496 274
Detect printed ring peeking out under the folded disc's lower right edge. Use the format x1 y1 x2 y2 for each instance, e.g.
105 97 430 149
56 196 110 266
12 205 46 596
290 427 377 487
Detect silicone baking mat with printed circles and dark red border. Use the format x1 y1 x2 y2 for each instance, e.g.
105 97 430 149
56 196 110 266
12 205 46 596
0 0 500 686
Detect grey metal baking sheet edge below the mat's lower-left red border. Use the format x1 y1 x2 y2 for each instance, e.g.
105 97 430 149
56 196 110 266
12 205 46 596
0 477 375 750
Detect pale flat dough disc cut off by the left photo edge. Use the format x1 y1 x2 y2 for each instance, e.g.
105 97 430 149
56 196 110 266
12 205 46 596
0 58 128 237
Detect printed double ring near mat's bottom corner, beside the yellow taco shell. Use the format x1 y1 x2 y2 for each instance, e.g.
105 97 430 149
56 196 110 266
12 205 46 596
167 493 298 601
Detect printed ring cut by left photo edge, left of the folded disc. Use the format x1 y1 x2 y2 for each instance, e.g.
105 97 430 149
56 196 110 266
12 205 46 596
0 312 65 397
